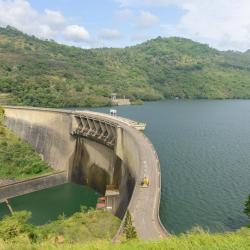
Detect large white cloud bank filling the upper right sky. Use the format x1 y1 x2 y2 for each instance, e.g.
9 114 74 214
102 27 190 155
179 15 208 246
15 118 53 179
116 0 250 50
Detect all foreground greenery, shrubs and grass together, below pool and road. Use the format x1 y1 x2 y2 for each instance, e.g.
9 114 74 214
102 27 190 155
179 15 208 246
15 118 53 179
0 211 250 250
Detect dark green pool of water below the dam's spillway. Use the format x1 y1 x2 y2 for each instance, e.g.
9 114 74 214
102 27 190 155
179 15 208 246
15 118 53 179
0 183 100 225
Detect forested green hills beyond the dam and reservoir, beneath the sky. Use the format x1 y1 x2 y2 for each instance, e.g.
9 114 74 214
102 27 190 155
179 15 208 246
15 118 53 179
0 27 250 107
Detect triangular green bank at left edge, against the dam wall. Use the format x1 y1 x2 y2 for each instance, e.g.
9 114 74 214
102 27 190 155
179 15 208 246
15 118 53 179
0 106 52 179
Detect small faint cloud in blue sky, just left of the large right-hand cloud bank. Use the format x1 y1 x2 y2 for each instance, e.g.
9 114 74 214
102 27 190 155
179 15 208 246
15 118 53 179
136 10 160 29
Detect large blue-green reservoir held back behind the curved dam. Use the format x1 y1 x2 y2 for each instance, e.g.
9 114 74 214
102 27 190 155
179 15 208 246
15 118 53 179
87 100 250 234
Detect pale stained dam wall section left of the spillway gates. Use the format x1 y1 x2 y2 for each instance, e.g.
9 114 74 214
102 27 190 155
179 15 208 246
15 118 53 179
5 107 75 170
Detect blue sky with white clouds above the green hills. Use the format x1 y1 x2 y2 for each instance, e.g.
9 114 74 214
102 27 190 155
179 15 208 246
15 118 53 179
0 0 250 51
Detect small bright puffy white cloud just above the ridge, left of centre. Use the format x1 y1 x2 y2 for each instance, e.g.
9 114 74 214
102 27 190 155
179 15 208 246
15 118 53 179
63 25 90 42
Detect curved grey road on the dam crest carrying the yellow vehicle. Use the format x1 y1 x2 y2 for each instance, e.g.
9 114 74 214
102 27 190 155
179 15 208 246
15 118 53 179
126 128 168 239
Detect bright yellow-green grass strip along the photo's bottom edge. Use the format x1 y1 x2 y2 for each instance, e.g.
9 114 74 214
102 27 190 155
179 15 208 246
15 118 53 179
0 225 250 250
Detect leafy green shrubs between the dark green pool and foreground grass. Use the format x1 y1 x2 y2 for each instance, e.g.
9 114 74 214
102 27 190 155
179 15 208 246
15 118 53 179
0 210 120 246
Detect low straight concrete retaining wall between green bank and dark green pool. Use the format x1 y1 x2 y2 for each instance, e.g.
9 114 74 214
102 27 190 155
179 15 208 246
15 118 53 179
0 171 67 201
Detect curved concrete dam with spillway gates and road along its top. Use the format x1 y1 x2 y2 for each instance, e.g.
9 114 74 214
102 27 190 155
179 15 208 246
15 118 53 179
0 107 168 239
